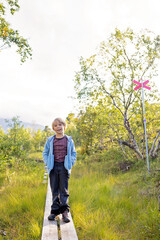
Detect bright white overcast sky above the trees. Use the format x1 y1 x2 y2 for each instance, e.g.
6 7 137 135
0 0 160 126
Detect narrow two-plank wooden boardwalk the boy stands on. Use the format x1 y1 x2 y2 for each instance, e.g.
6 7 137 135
41 181 78 240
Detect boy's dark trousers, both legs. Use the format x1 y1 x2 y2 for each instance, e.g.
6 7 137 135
49 162 69 215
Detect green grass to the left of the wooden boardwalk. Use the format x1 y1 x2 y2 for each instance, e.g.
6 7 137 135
0 157 47 240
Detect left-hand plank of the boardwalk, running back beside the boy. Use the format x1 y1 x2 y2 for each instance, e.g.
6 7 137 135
41 180 58 240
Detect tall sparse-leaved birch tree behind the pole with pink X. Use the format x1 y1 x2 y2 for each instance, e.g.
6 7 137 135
75 28 160 159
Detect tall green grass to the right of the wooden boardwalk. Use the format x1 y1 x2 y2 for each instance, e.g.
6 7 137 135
70 153 160 240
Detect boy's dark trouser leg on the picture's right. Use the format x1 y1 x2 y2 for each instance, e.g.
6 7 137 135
59 163 70 213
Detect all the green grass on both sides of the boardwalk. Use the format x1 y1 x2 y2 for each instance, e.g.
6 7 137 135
0 150 160 240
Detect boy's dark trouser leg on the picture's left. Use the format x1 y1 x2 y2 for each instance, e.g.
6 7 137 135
49 164 60 215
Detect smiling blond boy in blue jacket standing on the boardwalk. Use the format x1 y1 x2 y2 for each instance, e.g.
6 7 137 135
43 118 76 223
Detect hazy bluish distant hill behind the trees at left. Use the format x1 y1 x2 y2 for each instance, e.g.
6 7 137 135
0 118 45 132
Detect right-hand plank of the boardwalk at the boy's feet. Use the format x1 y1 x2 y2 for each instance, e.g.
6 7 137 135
60 213 78 240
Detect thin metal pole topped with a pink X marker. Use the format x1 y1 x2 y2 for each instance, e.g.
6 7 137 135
133 78 151 173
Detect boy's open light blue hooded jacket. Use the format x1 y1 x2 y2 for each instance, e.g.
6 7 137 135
43 135 77 174
